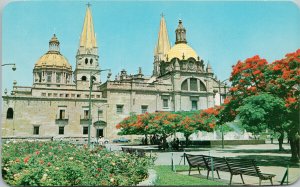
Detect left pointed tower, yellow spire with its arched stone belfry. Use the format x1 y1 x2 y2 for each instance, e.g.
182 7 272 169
74 4 100 89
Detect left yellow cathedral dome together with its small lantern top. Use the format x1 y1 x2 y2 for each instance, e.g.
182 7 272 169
34 34 72 70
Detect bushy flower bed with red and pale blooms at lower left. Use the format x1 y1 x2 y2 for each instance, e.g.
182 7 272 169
2 142 153 186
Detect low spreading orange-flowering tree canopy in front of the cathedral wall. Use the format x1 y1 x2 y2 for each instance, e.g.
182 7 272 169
116 108 219 148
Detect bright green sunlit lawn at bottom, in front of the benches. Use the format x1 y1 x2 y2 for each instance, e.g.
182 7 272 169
154 166 227 186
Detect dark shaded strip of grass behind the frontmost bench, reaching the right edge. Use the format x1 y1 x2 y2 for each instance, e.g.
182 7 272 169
229 155 300 168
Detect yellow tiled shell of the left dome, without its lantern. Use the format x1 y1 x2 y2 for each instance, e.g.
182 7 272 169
34 52 72 70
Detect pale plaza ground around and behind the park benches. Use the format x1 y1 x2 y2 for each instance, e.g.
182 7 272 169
107 142 300 185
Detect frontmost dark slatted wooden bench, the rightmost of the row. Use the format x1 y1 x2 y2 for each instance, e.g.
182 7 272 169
226 158 276 185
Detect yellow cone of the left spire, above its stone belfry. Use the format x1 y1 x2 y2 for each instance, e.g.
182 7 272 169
80 4 97 48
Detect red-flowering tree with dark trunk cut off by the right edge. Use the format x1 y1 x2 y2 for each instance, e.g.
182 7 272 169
267 49 300 161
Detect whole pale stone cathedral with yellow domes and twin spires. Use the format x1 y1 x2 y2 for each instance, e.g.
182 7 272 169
2 6 226 139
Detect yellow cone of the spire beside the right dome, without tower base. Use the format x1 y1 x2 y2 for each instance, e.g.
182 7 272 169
154 14 171 60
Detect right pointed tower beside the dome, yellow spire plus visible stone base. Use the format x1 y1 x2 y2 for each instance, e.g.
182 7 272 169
153 14 171 76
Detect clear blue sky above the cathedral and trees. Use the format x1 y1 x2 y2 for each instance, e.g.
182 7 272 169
2 1 300 91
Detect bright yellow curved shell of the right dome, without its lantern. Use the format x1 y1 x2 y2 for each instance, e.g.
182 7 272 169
167 43 198 61
